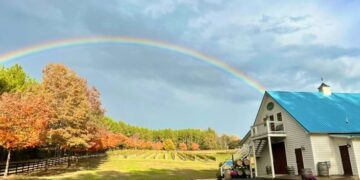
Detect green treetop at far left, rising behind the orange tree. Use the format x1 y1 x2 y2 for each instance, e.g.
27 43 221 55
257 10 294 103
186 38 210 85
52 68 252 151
0 64 36 95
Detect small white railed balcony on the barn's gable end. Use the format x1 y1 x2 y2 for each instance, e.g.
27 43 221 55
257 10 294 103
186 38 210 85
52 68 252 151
251 121 285 137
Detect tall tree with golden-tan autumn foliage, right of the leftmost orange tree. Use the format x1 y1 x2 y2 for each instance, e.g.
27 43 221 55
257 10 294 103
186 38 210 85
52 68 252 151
42 64 93 154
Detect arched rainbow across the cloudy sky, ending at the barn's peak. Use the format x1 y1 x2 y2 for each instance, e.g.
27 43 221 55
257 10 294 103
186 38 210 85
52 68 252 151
0 36 265 93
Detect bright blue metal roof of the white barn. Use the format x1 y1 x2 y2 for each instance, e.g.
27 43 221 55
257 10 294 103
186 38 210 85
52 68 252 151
267 91 360 133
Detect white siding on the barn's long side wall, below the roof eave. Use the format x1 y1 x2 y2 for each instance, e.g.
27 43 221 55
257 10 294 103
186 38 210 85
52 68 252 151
311 135 360 175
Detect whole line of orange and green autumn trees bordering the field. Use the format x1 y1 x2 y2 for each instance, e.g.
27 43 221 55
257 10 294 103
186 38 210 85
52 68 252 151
0 64 239 175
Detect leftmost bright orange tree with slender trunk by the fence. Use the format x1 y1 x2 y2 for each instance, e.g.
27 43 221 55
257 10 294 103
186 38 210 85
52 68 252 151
0 93 51 178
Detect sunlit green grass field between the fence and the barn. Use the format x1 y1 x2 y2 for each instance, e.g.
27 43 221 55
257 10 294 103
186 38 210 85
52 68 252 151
11 150 231 179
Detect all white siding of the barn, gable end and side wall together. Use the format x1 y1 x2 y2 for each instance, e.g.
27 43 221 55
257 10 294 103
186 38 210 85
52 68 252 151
254 95 360 177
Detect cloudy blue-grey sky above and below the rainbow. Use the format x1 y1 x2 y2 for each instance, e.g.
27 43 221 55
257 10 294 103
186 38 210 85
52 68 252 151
0 0 360 137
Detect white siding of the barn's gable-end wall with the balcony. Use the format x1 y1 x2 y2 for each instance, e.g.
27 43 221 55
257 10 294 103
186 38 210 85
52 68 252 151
255 96 315 175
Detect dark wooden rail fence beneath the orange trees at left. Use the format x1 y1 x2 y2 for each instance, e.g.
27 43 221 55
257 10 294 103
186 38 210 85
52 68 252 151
0 154 105 176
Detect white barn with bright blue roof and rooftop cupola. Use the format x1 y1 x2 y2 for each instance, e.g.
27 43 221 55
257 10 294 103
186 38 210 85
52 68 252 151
242 83 360 178
